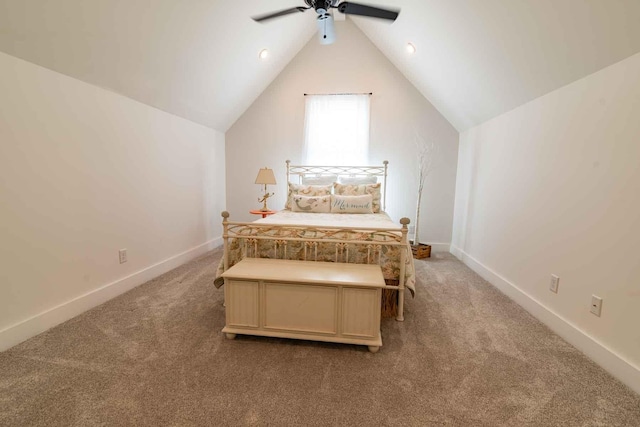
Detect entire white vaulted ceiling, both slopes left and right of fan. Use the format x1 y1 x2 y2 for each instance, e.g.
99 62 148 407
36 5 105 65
0 0 640 132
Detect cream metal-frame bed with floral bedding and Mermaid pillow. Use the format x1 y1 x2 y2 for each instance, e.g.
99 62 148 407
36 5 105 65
214 160 415 321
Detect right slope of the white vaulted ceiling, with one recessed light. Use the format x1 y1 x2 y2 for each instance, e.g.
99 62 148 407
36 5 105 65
354 0 640 131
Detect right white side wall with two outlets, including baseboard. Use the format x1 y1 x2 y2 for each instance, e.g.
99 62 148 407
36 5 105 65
452 54 640 392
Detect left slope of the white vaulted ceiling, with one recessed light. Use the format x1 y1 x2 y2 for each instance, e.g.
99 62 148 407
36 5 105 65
0 0 315 132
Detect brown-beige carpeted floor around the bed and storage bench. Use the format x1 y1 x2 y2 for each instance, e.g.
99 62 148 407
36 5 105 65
0 250 640 426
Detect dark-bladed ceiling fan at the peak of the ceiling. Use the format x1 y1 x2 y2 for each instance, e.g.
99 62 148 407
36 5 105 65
251 0 400 44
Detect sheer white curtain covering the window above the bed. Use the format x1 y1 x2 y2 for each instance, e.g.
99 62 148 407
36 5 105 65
302 95 370 166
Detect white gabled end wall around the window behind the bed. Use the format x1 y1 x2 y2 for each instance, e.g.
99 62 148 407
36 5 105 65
226 20 458 250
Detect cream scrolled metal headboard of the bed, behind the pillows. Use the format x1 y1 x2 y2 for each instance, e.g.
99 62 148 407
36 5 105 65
286 160 389 211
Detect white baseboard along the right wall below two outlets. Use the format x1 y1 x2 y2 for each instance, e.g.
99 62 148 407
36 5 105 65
451 245 640 394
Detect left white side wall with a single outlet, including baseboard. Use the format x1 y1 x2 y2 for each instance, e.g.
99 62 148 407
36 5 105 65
0 53 225 350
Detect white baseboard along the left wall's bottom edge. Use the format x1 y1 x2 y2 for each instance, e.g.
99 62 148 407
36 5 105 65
0 237 222 351
